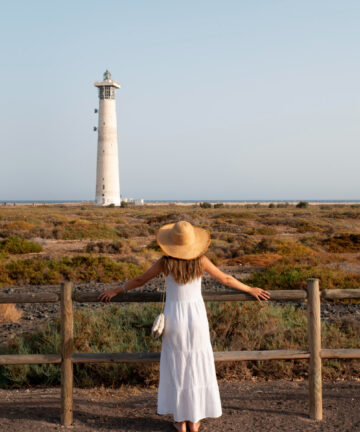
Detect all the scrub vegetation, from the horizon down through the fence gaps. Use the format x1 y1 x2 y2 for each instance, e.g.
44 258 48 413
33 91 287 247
0 203 360 386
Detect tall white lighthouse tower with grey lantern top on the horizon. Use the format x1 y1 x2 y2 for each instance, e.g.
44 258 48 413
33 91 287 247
94 71 121 206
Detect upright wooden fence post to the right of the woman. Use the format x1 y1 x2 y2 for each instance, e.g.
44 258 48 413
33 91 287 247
306 278 322 420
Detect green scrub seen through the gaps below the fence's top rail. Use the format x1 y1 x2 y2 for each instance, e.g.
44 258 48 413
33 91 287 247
0 302 360 388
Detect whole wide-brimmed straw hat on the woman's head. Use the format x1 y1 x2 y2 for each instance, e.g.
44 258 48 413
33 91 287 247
156 221 210 260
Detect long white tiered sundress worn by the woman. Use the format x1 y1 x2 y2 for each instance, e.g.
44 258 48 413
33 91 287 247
157 275 222 423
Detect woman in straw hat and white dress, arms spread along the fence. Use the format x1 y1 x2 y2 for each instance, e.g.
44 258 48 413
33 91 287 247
99 221 270 432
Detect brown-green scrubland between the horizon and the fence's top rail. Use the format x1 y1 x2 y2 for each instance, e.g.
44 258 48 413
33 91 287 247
0 203 360 289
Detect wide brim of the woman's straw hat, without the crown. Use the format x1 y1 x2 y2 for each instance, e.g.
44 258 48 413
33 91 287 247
156 223 211 260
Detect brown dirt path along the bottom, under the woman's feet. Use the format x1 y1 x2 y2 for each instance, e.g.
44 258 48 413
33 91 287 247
0 381 360 432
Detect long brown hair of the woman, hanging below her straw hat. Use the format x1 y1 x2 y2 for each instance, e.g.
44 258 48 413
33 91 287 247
161 255 204 284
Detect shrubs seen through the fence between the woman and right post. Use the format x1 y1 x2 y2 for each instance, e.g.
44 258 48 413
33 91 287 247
211 302 307 380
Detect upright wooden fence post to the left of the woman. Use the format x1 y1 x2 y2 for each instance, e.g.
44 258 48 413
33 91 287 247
61 282 73 426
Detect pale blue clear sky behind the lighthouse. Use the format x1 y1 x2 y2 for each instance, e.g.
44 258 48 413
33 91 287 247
0 0 360 201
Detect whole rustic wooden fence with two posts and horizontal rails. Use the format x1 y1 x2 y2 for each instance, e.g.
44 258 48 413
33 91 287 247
0 278 360 426
